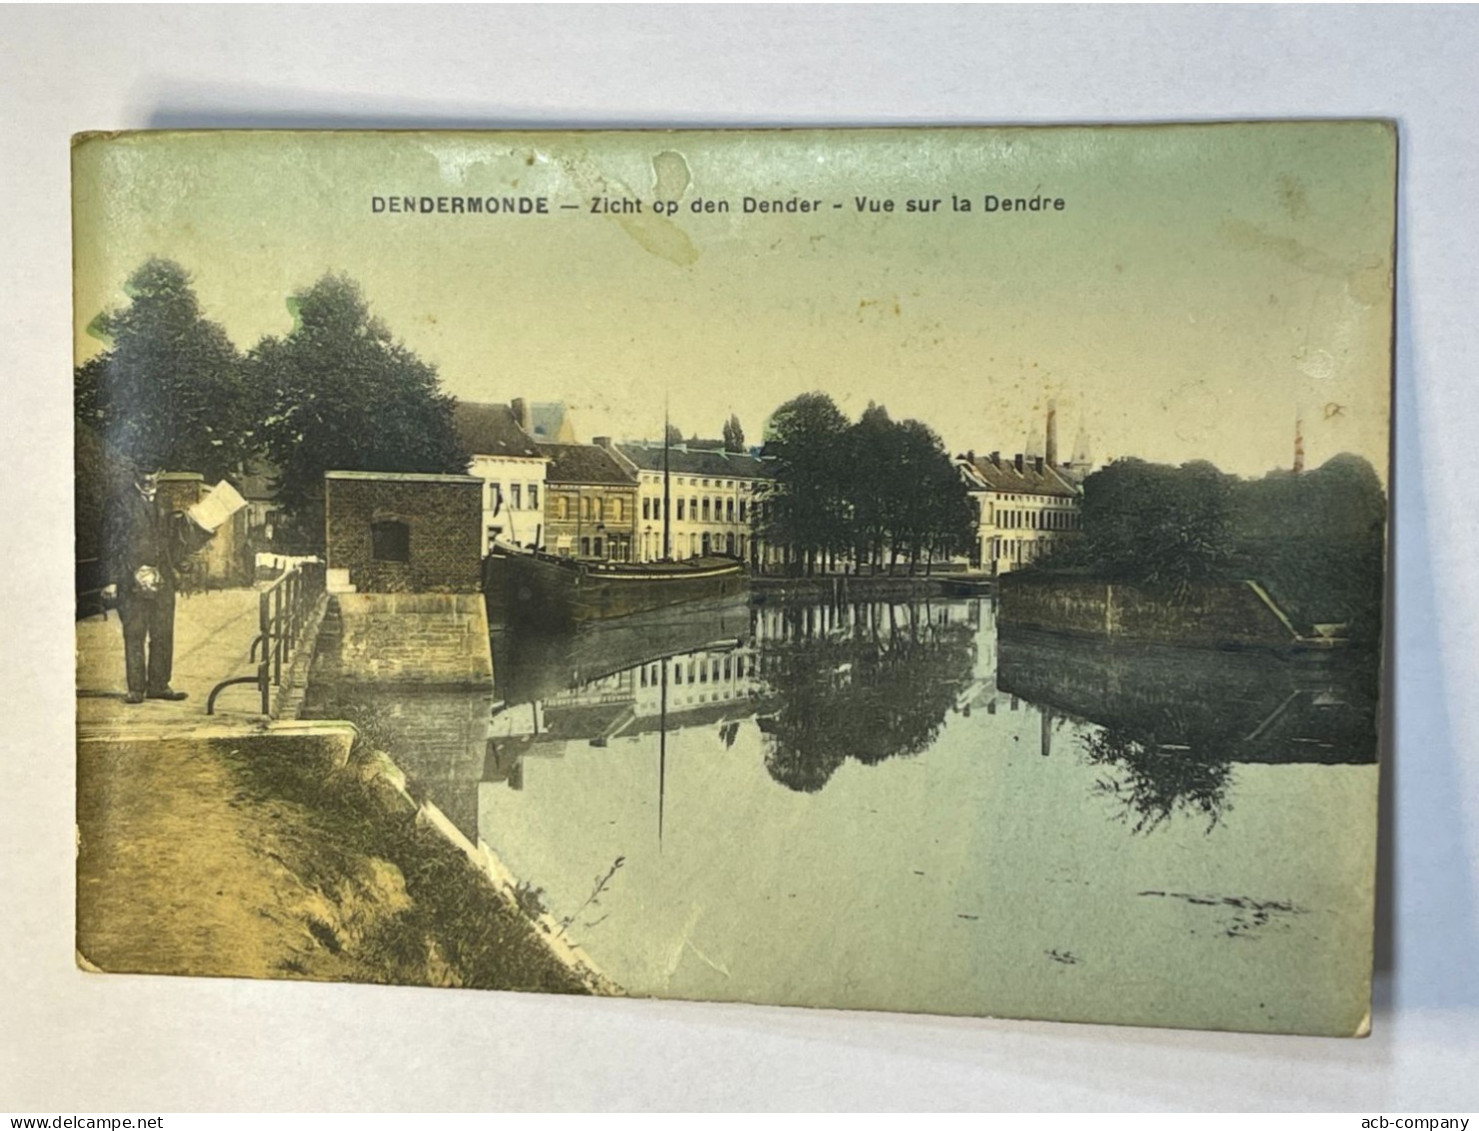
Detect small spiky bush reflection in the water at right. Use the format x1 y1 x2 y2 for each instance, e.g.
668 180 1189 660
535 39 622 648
1083 708 1235 832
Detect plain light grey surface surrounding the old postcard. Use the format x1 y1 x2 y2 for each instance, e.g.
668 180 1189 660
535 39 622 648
0 6 1479 1113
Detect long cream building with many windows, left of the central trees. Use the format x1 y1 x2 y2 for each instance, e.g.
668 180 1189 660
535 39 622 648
612 441 769 562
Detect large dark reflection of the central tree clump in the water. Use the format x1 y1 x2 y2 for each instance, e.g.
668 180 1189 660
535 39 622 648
762 605 976 792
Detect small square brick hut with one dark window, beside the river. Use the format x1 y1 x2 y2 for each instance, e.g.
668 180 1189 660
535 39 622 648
324 472 484 593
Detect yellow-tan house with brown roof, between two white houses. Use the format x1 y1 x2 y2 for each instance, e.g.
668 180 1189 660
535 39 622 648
538 441 637 562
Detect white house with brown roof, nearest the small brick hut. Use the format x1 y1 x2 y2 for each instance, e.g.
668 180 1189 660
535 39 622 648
453 399 550 550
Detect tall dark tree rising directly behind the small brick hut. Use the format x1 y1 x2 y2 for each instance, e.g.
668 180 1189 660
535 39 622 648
248 275 469 510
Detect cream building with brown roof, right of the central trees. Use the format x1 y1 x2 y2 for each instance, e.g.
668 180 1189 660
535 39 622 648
957 452 1080 574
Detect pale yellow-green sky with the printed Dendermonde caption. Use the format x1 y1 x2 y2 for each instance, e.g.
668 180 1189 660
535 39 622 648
72 121 1396 480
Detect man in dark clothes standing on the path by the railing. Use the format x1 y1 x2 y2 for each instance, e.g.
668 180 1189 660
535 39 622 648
104 472 185 704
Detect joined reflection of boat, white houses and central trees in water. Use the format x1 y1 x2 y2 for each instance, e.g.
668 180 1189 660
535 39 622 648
484 602 981 792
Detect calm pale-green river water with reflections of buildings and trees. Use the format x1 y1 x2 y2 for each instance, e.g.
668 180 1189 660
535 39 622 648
387 599 1377 1033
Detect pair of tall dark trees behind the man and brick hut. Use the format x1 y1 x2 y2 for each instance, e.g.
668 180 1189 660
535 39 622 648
74 259 469 552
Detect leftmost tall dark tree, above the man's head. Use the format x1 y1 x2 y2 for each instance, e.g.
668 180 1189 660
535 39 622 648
74 259 256 479
